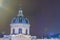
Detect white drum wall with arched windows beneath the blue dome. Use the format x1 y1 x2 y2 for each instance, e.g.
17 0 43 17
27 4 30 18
10 24 30 34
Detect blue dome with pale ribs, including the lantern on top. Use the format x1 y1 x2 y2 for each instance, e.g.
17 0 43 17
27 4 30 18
11 8 29 24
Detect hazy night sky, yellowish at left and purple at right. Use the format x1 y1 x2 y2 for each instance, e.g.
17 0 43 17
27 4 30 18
0 0 60 36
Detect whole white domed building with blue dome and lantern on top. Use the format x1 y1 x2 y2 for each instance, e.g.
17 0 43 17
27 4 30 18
0 8 60 40
